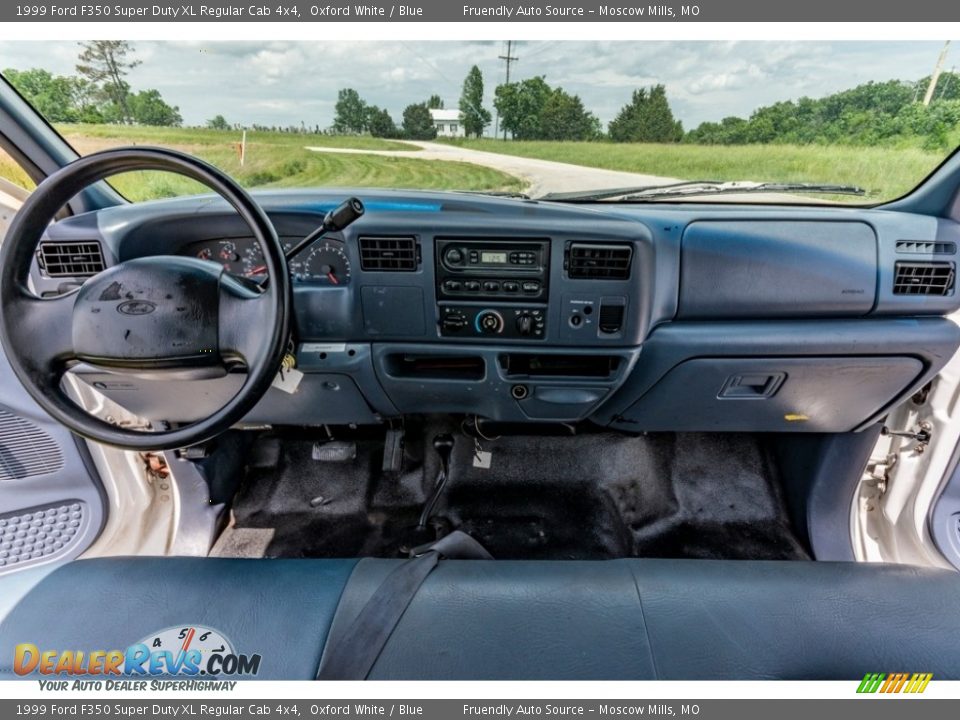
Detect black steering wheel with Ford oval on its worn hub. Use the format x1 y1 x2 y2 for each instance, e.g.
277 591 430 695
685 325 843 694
0 148 290 450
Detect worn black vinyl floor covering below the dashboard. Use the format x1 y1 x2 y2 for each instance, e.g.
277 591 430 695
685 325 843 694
233 424 808 559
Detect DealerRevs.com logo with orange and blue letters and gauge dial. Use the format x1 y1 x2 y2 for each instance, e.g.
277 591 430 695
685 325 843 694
13 625 260 678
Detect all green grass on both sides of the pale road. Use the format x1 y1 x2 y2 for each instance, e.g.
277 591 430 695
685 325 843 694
0 125 944 202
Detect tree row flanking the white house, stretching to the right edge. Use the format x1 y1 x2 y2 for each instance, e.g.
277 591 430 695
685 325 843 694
334 67 960 150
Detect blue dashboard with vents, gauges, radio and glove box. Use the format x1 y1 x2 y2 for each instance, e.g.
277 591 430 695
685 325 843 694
33 190 960 432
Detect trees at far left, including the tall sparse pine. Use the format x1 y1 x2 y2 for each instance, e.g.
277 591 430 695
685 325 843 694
3 40 183 127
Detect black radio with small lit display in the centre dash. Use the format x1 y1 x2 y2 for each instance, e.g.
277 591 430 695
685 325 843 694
436 238 550 302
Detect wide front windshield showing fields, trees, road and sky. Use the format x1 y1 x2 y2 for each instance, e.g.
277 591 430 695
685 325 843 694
0 40 960 204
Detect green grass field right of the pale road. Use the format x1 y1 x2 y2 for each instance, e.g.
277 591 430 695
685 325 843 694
444 139 946 202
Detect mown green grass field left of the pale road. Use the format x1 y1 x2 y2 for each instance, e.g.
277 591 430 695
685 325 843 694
0 125 522 200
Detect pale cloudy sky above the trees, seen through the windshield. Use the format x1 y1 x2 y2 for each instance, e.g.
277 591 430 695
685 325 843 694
0 41 960 129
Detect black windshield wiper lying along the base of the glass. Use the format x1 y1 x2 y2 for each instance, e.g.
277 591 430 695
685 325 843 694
537 180 866 202
